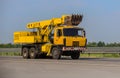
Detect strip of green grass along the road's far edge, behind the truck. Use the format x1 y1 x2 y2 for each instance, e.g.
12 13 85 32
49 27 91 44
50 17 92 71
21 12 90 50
0 52 120 58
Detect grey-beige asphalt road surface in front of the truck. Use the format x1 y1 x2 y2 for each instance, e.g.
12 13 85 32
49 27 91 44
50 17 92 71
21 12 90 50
0 56 120 78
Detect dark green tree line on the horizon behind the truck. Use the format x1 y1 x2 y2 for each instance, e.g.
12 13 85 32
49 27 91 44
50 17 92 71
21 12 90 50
0 41 120 48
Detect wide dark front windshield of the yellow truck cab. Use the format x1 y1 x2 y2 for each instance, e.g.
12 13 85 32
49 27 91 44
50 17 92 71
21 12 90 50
63 28 84 36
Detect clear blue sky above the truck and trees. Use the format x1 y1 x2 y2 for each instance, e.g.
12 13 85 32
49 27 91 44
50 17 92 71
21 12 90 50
0 0 120 43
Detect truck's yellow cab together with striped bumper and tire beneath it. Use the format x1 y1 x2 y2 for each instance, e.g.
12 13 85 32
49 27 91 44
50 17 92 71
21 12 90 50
50 26 87 59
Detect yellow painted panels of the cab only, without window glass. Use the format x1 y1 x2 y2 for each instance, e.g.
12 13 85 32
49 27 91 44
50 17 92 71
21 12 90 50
54 26 86 47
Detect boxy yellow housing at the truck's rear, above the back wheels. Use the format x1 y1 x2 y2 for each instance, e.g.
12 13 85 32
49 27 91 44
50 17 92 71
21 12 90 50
14 31 41 44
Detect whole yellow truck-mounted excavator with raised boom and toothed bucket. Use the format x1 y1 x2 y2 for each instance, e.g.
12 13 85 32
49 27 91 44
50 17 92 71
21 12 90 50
14 14 87 59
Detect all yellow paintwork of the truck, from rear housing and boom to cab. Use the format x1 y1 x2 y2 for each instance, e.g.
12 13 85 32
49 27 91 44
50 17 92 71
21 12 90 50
14 15 86 55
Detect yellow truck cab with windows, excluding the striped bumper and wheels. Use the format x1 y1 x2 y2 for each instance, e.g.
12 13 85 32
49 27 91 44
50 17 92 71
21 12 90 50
53 26 86 47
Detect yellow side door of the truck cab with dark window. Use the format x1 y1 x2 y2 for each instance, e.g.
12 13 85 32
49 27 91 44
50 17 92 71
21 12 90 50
54 29 64 45
